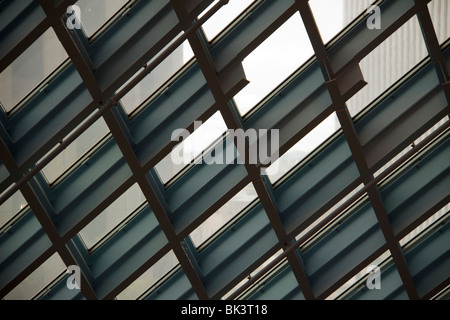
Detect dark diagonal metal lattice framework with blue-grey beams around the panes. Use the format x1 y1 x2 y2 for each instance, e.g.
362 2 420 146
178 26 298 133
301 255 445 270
0 0 450 299
